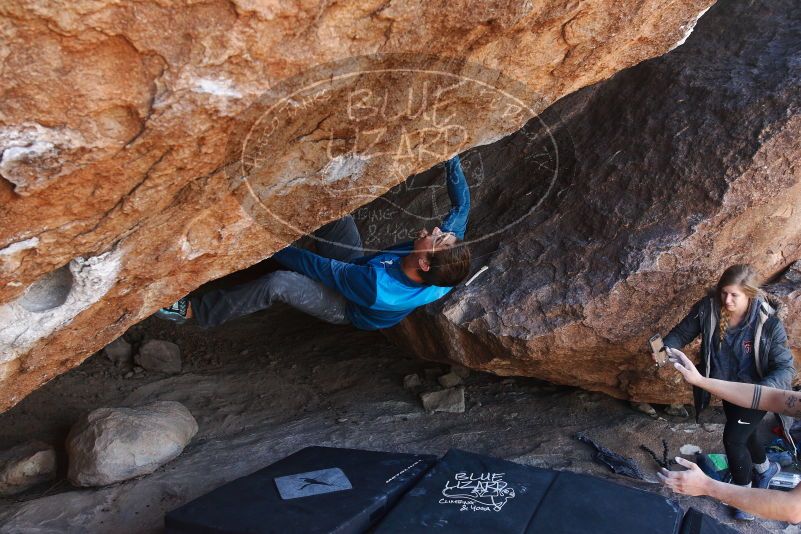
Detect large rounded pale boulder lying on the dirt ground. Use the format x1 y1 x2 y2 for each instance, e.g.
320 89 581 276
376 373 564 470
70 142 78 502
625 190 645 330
67 401 198 486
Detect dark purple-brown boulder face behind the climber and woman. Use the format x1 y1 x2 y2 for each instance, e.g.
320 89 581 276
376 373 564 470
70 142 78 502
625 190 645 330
380 1 801 403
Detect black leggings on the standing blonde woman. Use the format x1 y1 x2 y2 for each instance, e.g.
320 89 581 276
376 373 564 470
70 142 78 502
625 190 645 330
723 401 767 486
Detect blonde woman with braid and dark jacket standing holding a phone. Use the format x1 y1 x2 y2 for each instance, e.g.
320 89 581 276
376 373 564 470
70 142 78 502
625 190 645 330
664 265 795 521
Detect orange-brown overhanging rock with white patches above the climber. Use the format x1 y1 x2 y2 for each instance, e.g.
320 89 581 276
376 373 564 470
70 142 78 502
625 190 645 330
0 0 712 409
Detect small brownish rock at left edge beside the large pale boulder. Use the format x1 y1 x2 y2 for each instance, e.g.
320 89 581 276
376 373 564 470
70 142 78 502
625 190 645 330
0 441 56 496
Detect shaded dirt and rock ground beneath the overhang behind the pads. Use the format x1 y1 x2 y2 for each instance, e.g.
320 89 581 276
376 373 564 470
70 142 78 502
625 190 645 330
0 307 800 534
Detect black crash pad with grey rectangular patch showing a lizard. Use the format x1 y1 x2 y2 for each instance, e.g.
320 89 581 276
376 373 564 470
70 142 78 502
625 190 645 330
164 447 436 534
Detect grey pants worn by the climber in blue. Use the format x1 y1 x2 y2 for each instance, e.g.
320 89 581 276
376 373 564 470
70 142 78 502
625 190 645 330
190 215 363 327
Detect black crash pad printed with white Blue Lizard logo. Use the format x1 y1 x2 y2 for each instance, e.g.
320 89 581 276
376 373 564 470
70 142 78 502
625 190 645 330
375 449 682 534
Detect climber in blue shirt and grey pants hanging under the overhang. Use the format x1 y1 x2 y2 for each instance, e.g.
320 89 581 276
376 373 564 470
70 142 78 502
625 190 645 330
156 156 470 330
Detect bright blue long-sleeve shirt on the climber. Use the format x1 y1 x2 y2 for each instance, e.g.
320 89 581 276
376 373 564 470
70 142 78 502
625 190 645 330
273 156 470 330
